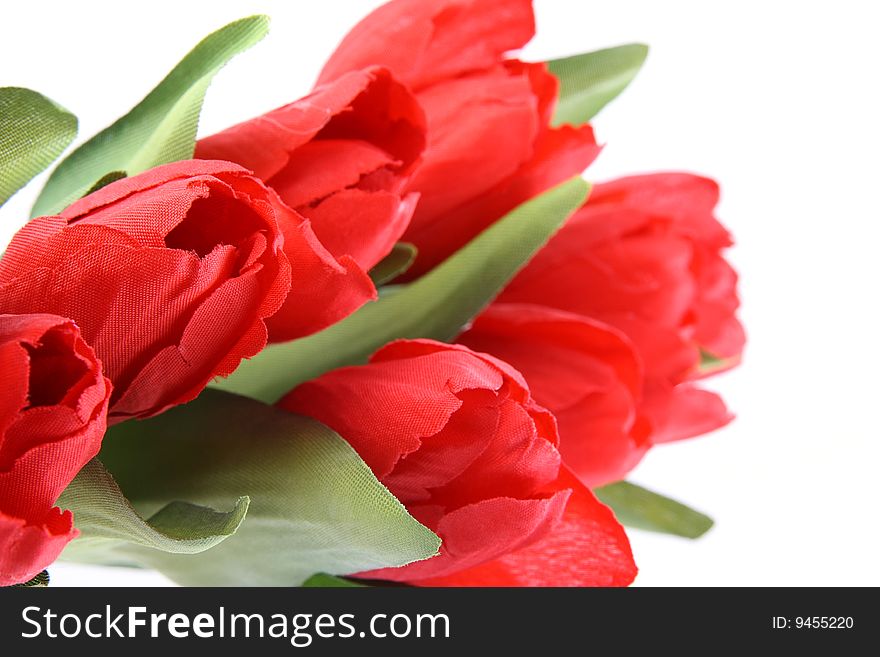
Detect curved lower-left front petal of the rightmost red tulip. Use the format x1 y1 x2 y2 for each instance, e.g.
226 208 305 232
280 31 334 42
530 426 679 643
457 303 652 488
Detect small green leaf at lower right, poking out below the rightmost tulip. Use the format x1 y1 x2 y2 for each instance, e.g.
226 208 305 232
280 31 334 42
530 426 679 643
593 481 714 538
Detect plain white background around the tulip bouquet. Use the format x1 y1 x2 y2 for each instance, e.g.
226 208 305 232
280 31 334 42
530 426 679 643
0 0 880 585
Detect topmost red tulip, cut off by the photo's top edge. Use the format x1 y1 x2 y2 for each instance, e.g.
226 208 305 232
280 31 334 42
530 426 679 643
319 0 599 276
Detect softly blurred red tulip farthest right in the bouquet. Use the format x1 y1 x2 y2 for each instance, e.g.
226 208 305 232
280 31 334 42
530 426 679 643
488 174 745 484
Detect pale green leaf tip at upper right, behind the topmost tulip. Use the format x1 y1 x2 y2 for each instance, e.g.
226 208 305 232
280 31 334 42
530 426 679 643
547 43 648 126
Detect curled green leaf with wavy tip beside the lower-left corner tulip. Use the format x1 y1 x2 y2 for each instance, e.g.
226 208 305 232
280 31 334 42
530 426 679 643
58 456 249 563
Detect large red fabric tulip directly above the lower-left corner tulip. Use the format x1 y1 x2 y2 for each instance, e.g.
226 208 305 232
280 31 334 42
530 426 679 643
0 161 296 421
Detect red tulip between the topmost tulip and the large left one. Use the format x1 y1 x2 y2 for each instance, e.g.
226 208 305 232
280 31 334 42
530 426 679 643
196 67 425 304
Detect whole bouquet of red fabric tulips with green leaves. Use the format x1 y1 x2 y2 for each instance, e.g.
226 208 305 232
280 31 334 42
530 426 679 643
0 0 744 586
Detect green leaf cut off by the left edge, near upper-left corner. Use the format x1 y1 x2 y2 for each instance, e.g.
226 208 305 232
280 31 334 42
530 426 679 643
0 87 77 205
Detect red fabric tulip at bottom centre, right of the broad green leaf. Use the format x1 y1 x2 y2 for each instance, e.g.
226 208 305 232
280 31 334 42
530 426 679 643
279 340 636 586
